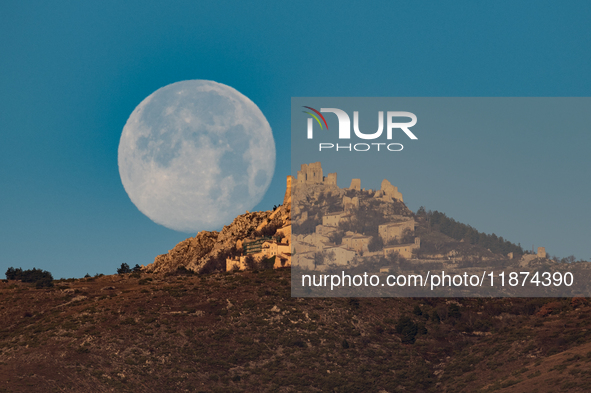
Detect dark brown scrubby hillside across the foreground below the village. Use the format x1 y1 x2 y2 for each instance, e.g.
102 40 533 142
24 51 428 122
0 269 591 393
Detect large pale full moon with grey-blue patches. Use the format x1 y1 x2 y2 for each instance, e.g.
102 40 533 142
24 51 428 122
118 80 275 232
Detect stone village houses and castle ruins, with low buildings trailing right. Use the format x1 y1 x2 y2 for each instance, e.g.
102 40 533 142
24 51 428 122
225 162 546 271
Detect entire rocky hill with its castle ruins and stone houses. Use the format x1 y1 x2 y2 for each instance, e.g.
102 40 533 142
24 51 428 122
142 162 549 273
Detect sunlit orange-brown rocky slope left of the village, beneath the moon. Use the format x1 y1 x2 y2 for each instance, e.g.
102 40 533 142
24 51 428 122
143 199 290 273
